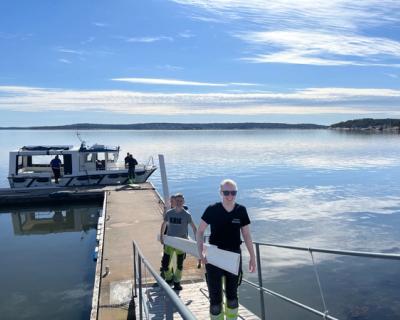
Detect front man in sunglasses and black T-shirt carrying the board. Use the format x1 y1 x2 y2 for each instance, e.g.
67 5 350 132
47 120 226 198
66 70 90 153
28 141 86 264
196 179 256 320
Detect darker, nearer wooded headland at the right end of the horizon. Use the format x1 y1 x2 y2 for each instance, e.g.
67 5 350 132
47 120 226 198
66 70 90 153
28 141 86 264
330 118 400 131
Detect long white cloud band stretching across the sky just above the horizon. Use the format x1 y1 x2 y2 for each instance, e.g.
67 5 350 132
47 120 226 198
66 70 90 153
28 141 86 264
0 85 400 117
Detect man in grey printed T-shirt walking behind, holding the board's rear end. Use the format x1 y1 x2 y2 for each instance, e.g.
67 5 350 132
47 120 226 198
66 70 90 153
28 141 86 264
160 193 197 291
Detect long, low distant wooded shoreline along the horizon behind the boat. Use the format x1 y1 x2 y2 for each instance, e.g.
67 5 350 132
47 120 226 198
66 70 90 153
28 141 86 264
0 122 327 130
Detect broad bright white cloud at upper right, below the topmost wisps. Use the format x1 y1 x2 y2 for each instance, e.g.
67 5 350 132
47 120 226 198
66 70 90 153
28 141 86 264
238 30 400 66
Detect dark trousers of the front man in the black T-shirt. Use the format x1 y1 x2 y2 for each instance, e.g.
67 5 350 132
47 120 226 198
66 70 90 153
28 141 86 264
206 257 242 306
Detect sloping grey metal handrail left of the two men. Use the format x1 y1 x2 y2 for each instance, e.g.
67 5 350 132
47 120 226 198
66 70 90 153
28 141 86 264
132 241 196 320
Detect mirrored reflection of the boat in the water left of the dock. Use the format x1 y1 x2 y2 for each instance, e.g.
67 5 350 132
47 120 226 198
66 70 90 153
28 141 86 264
11 207 100 235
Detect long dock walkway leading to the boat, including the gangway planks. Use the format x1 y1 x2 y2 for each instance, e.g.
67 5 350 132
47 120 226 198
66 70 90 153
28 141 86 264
91 183 259 320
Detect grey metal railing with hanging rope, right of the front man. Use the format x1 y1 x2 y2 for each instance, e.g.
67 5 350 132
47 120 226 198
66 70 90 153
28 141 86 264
247 242 400 320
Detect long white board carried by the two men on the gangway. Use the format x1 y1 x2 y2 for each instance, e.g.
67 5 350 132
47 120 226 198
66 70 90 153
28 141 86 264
164 235 240 275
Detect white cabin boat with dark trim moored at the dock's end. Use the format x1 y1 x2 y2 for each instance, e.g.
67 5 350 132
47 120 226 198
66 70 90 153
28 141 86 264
8 143 157 188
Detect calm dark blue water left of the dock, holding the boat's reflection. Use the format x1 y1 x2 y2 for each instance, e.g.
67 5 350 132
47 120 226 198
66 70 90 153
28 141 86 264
0 204 101 320
